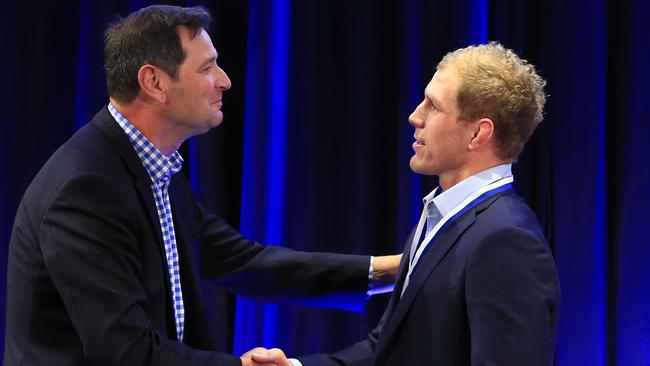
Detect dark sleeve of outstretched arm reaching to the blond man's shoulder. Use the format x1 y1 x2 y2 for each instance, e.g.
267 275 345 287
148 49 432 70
198 206 370 310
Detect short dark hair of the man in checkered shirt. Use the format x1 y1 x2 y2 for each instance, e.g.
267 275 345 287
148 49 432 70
104 5 212 104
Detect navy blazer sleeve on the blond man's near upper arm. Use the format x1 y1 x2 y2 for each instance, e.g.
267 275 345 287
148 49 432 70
466 228 559 366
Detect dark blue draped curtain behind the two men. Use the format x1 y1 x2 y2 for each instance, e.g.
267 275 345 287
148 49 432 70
0 0 650 366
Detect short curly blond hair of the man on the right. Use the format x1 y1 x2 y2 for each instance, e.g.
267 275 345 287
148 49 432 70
438 42 546 160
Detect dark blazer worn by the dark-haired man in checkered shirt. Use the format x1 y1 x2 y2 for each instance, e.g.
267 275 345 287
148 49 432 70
4 108 369 366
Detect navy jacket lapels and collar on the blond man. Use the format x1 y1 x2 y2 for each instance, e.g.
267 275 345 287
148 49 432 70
375 189 512 364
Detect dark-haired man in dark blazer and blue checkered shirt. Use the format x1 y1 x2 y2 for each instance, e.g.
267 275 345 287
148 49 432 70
4 6 399 366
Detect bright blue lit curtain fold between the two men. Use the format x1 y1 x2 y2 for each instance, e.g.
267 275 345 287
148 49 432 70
234 0 290 354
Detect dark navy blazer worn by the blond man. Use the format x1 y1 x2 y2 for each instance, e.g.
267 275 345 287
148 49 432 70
299 190 560 366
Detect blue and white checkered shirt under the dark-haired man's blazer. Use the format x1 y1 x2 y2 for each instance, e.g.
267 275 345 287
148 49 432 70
108 103 185 342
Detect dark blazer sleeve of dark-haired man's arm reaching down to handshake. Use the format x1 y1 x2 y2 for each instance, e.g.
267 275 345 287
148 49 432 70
39 174 241 365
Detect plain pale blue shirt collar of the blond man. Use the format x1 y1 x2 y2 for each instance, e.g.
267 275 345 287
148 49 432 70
422 164 512 217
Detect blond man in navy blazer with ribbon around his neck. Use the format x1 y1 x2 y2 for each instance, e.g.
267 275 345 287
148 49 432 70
252 43 560 366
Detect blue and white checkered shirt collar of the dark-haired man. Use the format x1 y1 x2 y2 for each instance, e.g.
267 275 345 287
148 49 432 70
108 103 183 183
